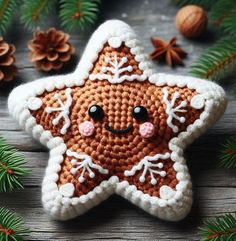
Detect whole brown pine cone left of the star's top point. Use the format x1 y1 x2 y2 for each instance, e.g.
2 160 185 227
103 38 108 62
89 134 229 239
28 28 75 71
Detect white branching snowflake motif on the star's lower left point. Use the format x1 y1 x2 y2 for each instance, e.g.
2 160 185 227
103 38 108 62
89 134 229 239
66 150 108 183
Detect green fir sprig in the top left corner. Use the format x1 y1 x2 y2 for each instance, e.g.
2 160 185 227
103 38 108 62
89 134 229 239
0 0 16 35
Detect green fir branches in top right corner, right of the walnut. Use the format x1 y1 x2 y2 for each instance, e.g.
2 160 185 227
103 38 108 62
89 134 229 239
174 0 236 84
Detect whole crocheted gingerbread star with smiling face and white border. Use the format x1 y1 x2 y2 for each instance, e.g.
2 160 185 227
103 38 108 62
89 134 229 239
8 20 226 221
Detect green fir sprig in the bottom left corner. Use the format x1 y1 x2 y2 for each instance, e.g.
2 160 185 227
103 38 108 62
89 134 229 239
0 208 30 241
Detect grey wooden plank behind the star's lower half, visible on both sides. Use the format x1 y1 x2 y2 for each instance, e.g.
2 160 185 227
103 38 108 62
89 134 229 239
17 151 236 188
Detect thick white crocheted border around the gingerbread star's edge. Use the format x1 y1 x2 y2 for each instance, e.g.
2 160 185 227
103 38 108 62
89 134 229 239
8 20 226 221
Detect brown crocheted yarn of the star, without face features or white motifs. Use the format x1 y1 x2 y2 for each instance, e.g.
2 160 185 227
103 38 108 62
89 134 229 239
32 45 202 197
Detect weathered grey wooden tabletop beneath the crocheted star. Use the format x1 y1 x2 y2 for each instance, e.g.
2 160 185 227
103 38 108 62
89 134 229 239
0 0 236 241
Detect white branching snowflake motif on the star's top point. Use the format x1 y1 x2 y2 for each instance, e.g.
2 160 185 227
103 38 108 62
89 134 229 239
89 54 146 83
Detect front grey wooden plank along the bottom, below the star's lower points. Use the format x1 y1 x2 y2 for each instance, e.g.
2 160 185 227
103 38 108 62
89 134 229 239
0 187 236 240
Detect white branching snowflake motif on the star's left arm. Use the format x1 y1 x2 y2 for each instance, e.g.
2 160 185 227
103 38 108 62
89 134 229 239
46 88 72 135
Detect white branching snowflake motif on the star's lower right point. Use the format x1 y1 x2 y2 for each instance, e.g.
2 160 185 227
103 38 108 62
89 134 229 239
124 152 170 185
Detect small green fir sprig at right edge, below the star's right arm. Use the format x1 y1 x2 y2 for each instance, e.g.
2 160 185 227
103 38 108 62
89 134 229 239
219 136 236 168
